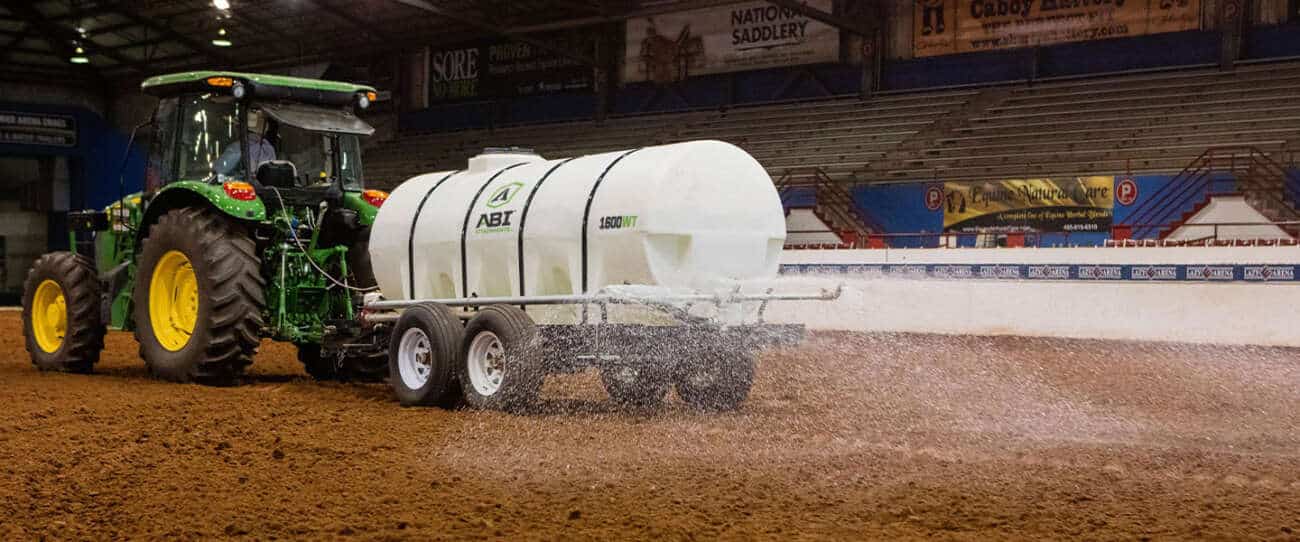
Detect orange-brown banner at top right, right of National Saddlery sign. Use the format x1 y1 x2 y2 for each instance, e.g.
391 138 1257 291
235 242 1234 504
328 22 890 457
913 0 1201 57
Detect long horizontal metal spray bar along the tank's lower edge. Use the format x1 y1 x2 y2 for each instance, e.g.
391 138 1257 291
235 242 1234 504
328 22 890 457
365 285 844 311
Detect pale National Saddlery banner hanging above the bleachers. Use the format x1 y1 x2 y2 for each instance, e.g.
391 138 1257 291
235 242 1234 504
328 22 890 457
623 0 840 83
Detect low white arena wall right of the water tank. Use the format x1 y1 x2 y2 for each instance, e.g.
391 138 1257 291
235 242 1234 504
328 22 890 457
767 247 1300 347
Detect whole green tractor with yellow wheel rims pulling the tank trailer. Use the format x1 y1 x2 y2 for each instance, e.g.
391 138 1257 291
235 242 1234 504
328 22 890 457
22 71 387 385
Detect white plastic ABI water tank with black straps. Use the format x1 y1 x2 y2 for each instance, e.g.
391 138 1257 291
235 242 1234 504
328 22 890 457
371 140 785 299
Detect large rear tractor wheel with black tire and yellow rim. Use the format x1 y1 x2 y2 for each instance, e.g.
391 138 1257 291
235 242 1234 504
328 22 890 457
134 208 264 385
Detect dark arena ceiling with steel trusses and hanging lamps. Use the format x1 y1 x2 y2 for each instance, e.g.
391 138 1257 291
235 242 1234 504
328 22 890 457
0 0 868 84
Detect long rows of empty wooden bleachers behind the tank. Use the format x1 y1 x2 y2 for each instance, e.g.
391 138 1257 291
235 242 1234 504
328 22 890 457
367 62 1300 187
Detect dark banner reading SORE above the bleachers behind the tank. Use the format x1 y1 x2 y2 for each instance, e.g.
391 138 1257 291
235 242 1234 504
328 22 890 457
429 36 595 101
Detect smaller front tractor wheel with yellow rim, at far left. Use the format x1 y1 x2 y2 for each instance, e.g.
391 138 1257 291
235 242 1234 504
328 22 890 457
22 252 104 373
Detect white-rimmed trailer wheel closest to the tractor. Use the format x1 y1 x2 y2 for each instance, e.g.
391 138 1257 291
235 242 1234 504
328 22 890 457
389 304 464 407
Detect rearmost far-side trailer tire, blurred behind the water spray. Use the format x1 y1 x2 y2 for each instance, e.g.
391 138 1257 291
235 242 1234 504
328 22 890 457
676 351 754 412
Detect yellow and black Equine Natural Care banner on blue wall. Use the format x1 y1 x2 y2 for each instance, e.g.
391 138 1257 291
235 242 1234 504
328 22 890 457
943 175 1115 233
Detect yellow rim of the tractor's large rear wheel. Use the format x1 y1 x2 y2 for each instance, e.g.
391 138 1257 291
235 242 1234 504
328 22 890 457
150 251 199 352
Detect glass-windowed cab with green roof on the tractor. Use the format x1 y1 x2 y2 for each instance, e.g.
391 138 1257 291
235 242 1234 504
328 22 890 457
142 71 376 207
